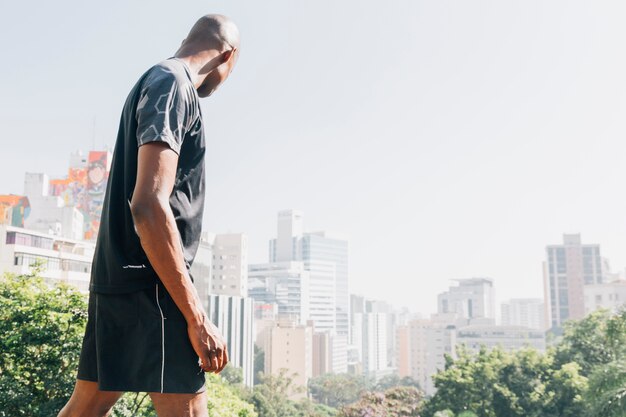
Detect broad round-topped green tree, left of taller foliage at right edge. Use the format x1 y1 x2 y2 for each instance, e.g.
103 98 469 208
424 348 586 417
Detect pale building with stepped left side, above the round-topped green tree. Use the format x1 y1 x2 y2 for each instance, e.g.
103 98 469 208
437 278 496 320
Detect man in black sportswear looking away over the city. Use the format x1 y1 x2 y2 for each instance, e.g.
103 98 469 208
59 15 239 417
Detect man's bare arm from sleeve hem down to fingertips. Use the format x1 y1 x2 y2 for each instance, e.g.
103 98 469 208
130 142 228 373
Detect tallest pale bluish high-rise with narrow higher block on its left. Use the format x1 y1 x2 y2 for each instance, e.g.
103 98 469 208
270 210 350 337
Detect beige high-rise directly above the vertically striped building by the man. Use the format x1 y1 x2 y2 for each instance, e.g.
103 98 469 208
211 233 248 297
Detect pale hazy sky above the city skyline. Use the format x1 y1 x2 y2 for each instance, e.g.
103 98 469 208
0 0 626 314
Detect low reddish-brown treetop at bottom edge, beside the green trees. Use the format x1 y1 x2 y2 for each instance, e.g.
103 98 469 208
339 387 423 417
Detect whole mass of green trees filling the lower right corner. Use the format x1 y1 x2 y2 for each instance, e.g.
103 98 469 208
423 311 626 417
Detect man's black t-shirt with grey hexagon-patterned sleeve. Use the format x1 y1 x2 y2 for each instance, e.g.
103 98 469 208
90 58 205 293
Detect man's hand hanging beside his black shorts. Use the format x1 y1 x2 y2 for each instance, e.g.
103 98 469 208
187 316 228 374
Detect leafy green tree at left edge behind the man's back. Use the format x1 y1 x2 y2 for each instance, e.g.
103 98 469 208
0 269 87 417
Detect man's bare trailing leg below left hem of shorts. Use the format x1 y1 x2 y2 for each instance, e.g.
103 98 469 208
57 379 123 417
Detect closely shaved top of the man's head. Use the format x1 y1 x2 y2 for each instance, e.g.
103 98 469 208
180 14 239 54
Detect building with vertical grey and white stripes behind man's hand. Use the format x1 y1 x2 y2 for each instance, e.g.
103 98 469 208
207 295 255 387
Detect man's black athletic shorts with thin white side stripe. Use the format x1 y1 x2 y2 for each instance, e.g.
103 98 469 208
77 282 206 393
